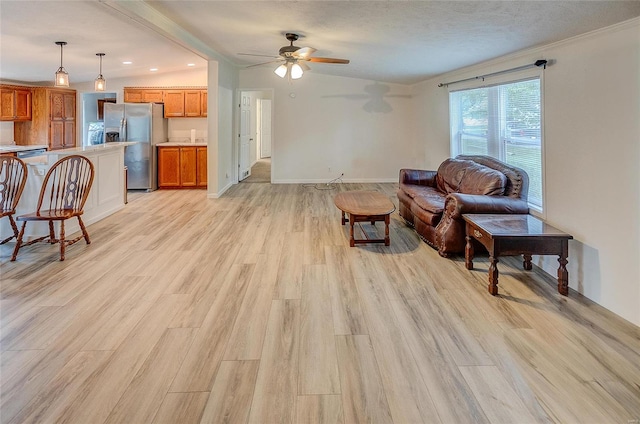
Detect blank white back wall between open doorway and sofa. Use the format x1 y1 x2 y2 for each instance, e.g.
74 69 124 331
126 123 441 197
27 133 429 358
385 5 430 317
240 65 424 183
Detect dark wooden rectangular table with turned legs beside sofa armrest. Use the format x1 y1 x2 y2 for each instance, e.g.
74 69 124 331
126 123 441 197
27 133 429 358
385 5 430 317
462 214 573 296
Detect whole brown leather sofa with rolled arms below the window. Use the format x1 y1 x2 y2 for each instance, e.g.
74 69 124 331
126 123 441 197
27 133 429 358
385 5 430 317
398 155 529 257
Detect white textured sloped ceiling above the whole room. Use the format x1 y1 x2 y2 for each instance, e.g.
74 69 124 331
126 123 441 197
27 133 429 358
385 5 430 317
0 0 640 83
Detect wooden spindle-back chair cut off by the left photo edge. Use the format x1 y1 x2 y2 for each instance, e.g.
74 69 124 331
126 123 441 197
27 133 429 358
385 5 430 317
0 155 27 244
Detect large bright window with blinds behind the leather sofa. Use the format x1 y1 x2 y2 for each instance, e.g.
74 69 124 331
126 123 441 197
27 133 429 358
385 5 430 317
449 78 543 211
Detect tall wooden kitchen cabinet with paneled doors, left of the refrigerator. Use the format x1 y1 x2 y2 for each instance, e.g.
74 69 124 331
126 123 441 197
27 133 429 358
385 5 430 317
13 87 76 150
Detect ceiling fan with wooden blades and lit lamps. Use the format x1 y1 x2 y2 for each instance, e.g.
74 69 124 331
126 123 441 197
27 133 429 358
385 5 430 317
238 32 349 79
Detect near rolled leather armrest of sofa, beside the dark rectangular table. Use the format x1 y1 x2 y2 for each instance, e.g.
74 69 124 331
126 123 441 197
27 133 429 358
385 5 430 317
444 193 529 219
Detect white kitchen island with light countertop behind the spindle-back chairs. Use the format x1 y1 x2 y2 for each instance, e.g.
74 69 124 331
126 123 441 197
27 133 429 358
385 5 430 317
0 142 135 240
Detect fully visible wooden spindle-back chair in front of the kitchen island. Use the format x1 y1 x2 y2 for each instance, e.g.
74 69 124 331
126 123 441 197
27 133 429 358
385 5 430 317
11 155 95 261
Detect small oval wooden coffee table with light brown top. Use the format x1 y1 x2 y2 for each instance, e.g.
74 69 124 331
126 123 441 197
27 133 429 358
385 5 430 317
333 191 396 247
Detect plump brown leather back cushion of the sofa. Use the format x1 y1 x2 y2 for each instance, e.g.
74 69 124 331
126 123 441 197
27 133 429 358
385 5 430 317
436 158 507 196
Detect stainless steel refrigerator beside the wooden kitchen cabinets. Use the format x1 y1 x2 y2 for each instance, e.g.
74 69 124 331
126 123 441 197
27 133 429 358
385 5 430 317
104 103 167 191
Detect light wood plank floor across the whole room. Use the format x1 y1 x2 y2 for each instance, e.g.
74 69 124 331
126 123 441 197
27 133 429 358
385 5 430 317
0 184 640 424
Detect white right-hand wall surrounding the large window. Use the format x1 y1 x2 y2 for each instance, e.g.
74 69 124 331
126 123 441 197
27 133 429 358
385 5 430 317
414 19 640 325
